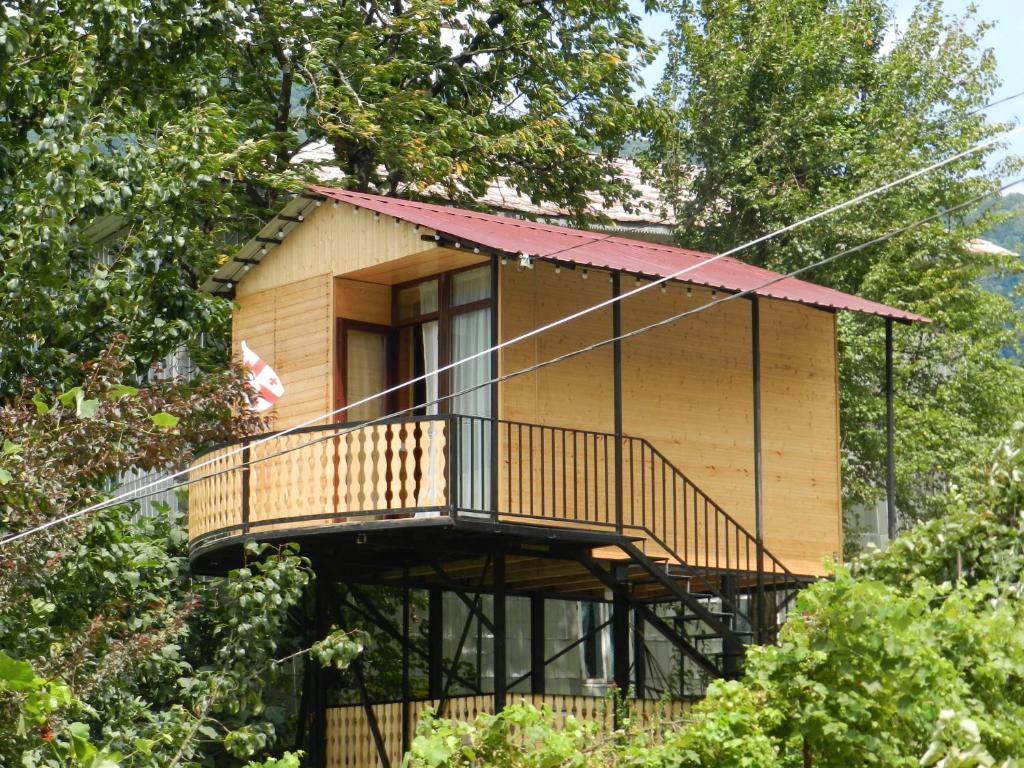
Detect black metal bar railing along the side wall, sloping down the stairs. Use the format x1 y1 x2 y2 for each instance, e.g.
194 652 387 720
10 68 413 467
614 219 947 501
455 416 800 640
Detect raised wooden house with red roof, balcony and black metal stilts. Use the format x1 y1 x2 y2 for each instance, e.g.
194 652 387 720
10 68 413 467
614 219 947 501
188 187 924 766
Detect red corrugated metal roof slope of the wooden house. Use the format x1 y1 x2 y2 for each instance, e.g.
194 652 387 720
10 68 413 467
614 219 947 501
309 185 929 323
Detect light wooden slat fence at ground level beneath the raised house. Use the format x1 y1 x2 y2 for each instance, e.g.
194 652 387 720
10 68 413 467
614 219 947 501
327 695 689 768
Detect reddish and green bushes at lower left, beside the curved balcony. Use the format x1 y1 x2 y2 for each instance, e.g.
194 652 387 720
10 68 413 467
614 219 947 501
0 356 331 768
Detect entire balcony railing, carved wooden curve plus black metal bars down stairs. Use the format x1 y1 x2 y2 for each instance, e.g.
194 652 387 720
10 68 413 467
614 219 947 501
189 415 798 625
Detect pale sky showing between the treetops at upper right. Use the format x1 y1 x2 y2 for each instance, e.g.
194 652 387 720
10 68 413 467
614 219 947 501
630 0 1024 168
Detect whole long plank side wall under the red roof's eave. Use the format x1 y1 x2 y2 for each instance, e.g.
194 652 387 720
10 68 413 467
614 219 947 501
499 263 842 575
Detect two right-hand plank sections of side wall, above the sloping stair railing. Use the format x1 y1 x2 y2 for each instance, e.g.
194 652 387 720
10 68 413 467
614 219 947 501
623 284 842 574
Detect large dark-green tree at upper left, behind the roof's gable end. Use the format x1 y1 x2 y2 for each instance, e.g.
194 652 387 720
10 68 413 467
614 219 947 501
0 0 651 397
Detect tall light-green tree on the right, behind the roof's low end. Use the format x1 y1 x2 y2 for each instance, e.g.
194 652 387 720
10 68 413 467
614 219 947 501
649 0 1024 518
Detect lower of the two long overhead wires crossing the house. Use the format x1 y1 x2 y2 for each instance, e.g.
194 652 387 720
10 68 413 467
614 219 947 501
0 177 1024 546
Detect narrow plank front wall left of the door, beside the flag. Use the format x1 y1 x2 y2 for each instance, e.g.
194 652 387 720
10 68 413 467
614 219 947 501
231 274 334 429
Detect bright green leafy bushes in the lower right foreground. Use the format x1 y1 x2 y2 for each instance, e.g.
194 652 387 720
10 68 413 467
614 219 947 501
407 424 1024 768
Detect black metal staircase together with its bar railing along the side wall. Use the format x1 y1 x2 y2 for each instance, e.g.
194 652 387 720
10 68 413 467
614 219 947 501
453 416 806 684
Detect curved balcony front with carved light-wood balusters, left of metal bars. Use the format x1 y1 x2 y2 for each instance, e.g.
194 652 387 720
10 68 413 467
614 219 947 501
188 416 452 573
